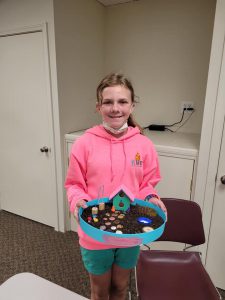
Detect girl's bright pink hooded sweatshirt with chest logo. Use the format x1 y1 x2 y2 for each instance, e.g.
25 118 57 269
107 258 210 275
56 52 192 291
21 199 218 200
65 125 160 250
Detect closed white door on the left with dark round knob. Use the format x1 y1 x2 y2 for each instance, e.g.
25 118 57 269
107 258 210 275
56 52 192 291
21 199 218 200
0 31 57 227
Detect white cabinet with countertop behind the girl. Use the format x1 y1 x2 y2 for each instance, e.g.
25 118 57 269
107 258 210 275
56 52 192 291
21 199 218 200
65 131 200 231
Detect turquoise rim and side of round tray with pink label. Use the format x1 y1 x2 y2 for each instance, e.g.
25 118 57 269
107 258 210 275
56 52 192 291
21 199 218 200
79 198 166 247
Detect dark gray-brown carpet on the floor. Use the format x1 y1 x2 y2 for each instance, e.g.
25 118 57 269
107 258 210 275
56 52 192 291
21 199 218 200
0 211 225 300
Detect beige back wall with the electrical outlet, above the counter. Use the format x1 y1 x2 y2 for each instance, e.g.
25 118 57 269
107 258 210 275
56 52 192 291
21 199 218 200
105 0 216 133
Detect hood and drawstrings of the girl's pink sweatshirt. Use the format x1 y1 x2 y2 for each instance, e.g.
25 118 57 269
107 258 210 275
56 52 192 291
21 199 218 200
86 125 140 182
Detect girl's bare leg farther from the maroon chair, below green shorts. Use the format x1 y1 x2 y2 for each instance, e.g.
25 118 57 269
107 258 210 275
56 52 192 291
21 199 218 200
89 269 111 300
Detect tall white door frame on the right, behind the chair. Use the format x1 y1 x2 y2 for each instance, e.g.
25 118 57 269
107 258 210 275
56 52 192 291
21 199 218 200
194 0 225 263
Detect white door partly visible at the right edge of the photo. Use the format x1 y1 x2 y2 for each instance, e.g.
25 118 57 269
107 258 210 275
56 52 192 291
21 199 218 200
206 118 225 289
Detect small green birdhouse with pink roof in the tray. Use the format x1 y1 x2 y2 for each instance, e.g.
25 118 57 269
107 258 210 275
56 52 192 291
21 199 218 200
109 185 134 211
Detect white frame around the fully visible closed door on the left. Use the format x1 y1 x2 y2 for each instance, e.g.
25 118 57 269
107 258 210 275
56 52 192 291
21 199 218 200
0 23 59 231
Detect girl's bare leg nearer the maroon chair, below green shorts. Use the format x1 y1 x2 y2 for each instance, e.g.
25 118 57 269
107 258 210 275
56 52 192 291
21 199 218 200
109 264 132 300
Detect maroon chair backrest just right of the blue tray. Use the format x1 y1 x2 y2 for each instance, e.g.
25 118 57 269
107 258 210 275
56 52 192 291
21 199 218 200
158 198 205 246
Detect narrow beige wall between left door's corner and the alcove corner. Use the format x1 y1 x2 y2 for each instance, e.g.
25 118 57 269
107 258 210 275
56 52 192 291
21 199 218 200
54 0 105 134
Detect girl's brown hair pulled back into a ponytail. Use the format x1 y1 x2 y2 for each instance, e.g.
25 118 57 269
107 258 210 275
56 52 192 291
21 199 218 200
97 73 143 133
